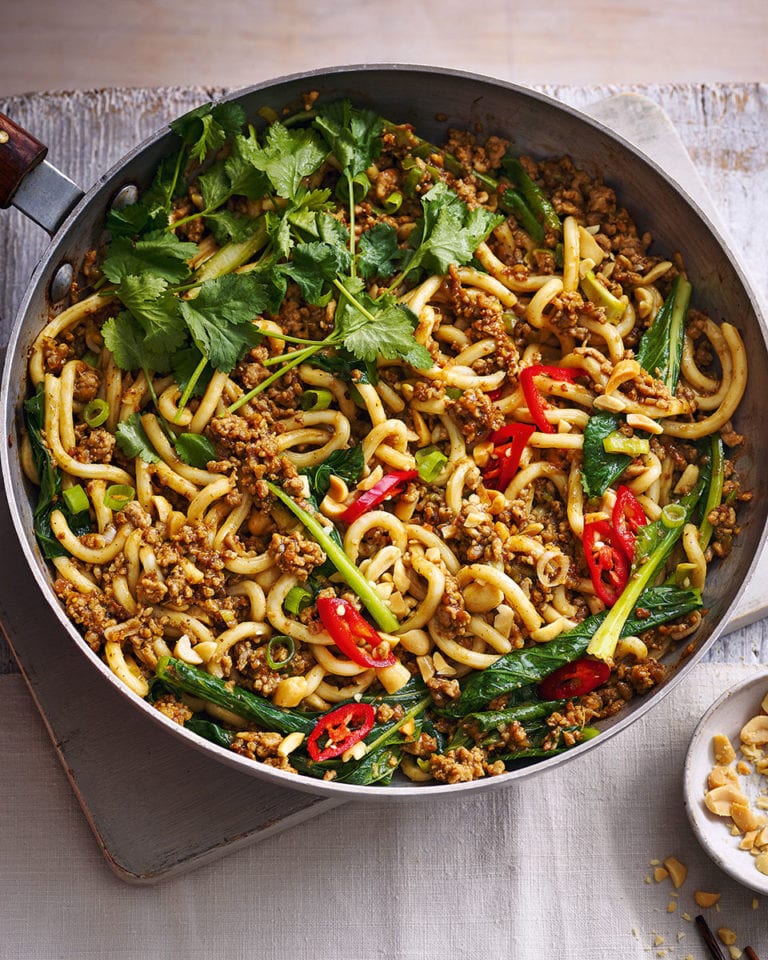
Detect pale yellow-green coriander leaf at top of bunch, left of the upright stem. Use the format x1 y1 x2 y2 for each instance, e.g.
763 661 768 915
241 122 326 200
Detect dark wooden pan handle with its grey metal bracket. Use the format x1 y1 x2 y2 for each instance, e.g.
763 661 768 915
0 113 83 234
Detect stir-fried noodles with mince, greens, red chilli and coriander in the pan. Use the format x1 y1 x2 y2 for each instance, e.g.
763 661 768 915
21 95 749 784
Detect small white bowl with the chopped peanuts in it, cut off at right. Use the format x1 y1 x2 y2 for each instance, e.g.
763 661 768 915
685 670 768 895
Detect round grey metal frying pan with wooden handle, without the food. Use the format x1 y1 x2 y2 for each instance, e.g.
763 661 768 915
0 65 768 799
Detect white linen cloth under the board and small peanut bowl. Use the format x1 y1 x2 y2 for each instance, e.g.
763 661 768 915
0 664 768 960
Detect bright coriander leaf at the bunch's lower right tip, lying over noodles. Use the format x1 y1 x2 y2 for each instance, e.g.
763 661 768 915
335 277 434 370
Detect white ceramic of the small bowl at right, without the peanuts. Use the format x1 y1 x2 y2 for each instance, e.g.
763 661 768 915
685 671 768 896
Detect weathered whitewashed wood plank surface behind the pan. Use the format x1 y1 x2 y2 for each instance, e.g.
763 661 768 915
0 84 768 672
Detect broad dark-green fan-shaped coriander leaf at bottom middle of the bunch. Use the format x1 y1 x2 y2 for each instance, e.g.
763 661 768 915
181 273 268 373
